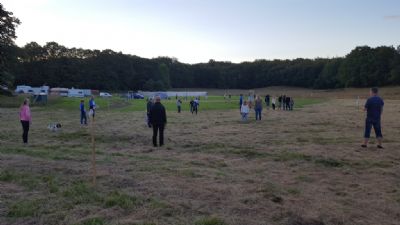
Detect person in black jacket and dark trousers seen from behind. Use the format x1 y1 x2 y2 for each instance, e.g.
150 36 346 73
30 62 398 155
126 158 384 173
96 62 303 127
149 96 167 147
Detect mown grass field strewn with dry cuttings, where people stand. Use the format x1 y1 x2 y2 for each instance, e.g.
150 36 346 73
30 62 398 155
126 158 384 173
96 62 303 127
0 88 400 225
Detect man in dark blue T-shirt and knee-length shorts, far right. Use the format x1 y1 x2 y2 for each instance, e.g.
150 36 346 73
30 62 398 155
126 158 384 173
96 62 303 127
361 87 384 148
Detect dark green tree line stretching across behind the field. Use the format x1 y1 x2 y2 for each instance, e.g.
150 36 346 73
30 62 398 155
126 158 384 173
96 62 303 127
0 4 400 91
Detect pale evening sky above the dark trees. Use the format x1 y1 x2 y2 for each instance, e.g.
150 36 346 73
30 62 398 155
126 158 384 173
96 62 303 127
2 0 400 63
